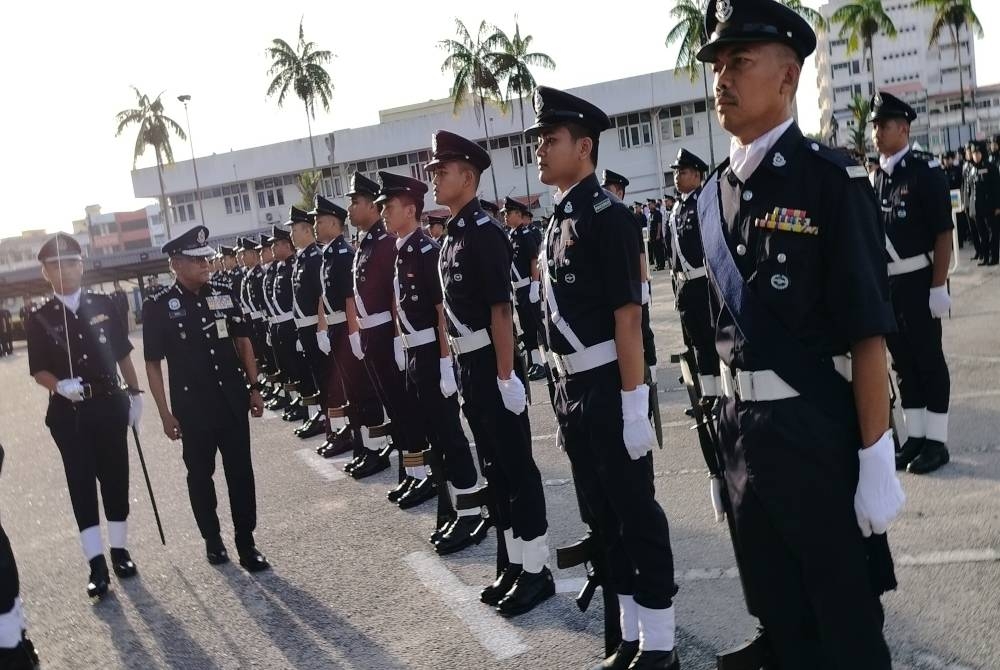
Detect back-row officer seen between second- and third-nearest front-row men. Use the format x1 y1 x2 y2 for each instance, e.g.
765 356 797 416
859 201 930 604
502 197 545 381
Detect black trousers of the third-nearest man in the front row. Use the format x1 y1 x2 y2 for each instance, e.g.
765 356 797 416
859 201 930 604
458 345 548 541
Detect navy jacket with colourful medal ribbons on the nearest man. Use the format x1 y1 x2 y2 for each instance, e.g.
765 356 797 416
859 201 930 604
701 124 895 370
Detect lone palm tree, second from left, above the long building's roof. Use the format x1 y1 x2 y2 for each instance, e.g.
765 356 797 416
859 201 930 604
267 19 333 170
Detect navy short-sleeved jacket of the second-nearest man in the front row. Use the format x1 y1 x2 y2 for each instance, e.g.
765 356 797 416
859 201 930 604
541 175 642 354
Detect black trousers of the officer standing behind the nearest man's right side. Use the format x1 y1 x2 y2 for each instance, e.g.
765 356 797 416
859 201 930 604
885 268 951 414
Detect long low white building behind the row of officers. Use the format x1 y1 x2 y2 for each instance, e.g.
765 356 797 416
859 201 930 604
132 70 744 246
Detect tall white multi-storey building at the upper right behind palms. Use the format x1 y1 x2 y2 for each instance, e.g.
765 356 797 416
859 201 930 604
816 0 976 152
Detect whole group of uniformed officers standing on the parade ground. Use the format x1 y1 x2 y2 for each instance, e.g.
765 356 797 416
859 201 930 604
0 0 984 670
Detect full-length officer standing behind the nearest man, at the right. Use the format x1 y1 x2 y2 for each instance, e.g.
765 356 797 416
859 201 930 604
869 92 953 474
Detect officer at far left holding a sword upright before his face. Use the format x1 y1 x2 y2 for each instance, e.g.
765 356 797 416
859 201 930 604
25 233 142 598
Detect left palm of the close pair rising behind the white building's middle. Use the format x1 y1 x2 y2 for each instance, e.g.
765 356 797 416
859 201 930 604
438 19 506 201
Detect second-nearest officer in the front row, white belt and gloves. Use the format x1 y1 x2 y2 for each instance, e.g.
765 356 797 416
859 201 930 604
528 86 679 670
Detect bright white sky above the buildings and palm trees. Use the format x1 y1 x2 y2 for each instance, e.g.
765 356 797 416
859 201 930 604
0 0 1000 237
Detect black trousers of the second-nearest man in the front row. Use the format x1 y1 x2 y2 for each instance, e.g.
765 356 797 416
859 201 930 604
554 363 677 609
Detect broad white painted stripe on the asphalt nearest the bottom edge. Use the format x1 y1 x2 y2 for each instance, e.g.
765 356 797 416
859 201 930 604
403 551 529 661
